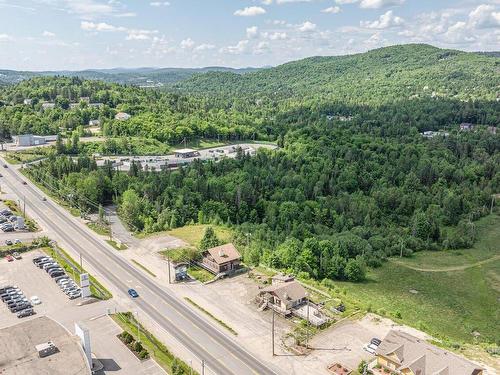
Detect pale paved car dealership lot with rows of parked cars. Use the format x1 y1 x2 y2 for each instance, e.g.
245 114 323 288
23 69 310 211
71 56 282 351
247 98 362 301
0 250 165 375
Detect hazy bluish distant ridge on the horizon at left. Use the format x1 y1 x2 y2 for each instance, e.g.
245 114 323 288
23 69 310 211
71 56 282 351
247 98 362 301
0 66 259 86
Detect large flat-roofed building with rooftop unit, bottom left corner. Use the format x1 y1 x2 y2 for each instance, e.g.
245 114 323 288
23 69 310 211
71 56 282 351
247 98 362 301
0 316 91 375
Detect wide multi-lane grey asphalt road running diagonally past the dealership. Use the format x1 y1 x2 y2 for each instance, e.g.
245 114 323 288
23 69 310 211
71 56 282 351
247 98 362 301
2 160 276 375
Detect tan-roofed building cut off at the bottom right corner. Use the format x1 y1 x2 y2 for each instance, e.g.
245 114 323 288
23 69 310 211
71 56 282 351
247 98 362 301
372 330 484 375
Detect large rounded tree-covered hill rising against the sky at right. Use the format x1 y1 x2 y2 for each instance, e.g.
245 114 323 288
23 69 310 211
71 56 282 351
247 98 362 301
177 44 500 103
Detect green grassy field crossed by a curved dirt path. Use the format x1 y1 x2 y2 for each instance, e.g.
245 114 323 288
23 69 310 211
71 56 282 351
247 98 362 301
341 215 500 343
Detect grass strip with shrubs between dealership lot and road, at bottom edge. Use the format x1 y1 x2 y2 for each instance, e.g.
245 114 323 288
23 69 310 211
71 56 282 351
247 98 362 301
111 313 198 375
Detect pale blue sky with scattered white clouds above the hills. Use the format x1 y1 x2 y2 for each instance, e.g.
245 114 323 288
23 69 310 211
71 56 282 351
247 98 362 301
0 0 500 70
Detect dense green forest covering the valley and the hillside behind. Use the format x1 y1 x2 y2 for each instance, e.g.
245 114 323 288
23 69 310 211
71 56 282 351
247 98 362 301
0 45 500 281
